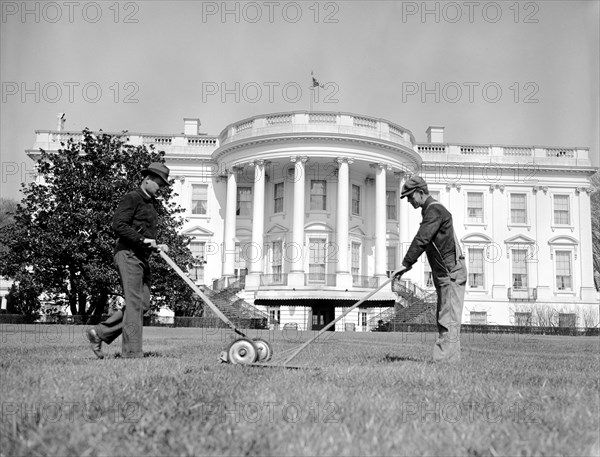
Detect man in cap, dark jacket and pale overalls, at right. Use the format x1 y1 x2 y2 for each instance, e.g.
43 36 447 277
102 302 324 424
396 176 467 362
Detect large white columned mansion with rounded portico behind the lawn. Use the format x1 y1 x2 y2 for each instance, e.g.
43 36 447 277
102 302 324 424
27 111 599 331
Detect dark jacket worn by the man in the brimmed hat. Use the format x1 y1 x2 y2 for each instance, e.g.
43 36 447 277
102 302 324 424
112 187 157 261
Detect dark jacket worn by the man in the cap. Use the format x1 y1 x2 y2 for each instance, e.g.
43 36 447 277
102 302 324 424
402 197 456 278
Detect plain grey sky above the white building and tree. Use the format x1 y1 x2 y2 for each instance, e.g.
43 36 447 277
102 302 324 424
0 0 600 199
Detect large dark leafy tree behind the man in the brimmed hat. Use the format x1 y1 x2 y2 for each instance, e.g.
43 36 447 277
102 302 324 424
0 129 198 315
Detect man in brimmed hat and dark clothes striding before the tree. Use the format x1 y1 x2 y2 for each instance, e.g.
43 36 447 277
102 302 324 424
87 162 169 359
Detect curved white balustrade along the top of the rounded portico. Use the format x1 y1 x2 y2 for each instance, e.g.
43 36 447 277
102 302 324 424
219 111 415 150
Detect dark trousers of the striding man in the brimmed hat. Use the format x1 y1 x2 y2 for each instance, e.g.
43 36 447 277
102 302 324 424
96 250 150 357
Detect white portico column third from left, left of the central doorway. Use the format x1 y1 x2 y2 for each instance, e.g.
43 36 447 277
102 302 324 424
286 156 308 274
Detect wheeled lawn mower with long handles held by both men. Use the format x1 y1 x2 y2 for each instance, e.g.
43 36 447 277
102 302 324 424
159 250 406 368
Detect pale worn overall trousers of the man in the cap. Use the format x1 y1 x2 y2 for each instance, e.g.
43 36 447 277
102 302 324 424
433 259 467 362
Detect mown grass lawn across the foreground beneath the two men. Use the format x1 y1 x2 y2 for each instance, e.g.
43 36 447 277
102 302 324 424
0 325 600 456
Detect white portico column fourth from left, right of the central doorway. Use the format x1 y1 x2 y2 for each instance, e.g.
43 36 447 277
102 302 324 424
336 157 352 273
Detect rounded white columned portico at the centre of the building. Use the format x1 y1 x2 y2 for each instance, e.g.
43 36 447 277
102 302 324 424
213 113 420 292
